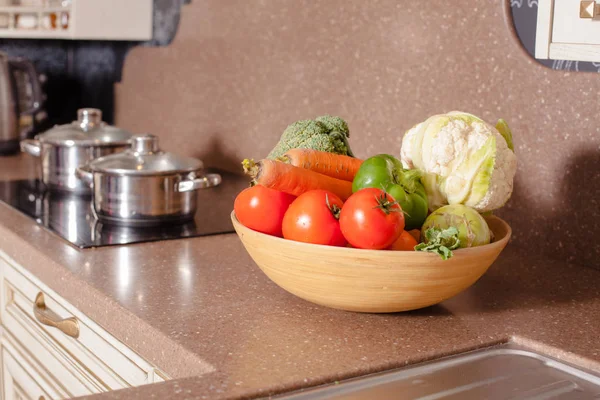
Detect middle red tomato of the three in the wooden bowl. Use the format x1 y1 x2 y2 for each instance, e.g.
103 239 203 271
283 190 347 246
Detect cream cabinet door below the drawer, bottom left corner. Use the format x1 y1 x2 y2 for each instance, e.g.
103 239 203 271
2 347 55 400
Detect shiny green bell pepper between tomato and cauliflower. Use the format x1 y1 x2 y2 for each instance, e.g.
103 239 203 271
352 154 427 230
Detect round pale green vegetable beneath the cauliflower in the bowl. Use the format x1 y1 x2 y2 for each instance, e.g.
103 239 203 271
421 204 491 248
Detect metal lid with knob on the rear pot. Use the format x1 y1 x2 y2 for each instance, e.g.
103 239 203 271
36 108 132 146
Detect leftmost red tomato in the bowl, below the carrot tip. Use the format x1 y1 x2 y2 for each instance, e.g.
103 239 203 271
233 185 296 237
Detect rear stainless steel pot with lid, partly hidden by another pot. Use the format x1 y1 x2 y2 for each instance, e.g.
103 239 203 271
21 108 132 193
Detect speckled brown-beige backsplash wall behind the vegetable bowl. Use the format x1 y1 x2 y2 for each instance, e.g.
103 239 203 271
116 0 600 267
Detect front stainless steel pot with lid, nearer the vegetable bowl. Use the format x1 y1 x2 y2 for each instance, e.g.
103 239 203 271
77 135 221 225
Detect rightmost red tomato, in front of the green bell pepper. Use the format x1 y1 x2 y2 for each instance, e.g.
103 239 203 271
340 188 404 250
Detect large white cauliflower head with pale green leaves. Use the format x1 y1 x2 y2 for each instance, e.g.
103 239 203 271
401 111 517 212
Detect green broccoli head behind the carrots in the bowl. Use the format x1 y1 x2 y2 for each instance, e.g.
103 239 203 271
267 115 354 159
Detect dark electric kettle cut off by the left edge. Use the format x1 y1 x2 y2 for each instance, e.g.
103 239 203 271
0 52 43 155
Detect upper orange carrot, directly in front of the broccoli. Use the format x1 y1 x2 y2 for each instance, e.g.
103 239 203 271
279 149 362 182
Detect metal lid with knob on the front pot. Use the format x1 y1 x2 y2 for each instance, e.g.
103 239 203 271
88 134 204 175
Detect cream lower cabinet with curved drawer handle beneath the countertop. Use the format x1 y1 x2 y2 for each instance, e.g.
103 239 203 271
0 252 168 400
